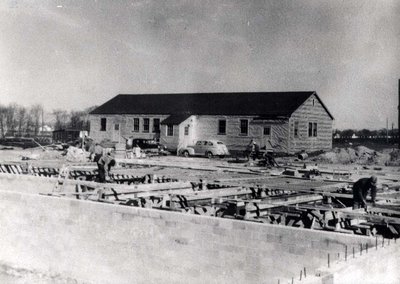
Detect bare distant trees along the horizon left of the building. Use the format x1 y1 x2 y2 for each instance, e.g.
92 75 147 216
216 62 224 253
0 104 95 137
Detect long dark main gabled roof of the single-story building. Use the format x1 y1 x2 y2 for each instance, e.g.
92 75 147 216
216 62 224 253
91 91 333 119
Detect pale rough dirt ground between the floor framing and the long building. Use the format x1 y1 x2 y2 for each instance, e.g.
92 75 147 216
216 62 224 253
0 146 400 184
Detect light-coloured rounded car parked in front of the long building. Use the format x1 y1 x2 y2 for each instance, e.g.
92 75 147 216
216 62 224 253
179 140 229 158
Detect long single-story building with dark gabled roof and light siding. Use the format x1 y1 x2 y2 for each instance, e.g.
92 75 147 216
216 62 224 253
89 91 334 153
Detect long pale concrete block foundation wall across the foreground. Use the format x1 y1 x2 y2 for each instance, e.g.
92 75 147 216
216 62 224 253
0 186 373 283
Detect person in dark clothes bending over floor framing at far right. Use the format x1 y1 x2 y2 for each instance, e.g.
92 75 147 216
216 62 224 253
353 176 378 209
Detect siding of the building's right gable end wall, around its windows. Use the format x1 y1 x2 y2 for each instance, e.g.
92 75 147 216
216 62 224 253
289 95 333 153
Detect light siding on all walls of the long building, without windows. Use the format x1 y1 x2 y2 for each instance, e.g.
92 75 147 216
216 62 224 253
90 95 333 153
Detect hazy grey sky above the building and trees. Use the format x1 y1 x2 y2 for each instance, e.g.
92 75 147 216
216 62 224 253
0 0 400 129
